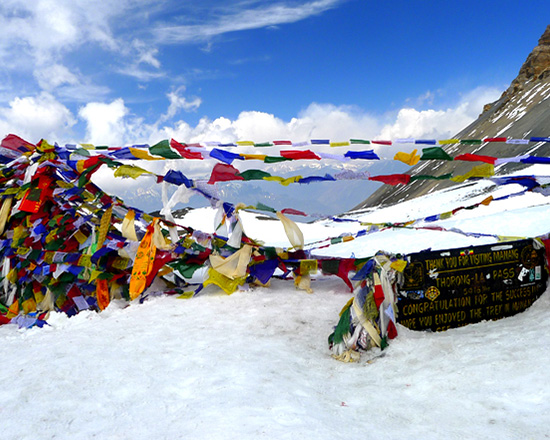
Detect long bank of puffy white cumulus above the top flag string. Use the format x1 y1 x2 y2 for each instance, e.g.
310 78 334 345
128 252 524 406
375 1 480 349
74 88 500 151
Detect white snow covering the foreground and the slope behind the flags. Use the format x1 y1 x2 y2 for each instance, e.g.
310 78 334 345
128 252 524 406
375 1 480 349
0 176 550 440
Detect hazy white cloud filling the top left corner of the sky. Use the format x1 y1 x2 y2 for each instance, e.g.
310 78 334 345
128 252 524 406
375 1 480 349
0 0 162 92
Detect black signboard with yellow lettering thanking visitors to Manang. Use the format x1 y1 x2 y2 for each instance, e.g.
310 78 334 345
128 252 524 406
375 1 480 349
397 240 548 331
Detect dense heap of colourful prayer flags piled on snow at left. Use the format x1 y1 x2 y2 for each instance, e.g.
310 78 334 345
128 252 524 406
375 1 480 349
0 135 376 327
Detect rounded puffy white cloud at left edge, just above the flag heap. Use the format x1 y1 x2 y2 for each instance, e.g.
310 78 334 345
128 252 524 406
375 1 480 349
0 92 76 142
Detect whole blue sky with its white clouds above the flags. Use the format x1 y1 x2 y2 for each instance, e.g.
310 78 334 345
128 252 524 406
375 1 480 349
0 0 550 145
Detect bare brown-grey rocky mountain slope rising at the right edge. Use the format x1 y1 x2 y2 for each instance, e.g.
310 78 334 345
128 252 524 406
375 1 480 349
354 25 550 209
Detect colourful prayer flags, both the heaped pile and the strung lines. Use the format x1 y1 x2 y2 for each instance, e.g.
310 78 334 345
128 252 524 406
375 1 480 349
0 131 548 330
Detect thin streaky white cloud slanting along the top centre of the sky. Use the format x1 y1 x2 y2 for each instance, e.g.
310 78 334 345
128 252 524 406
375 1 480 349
155 0 342 43
